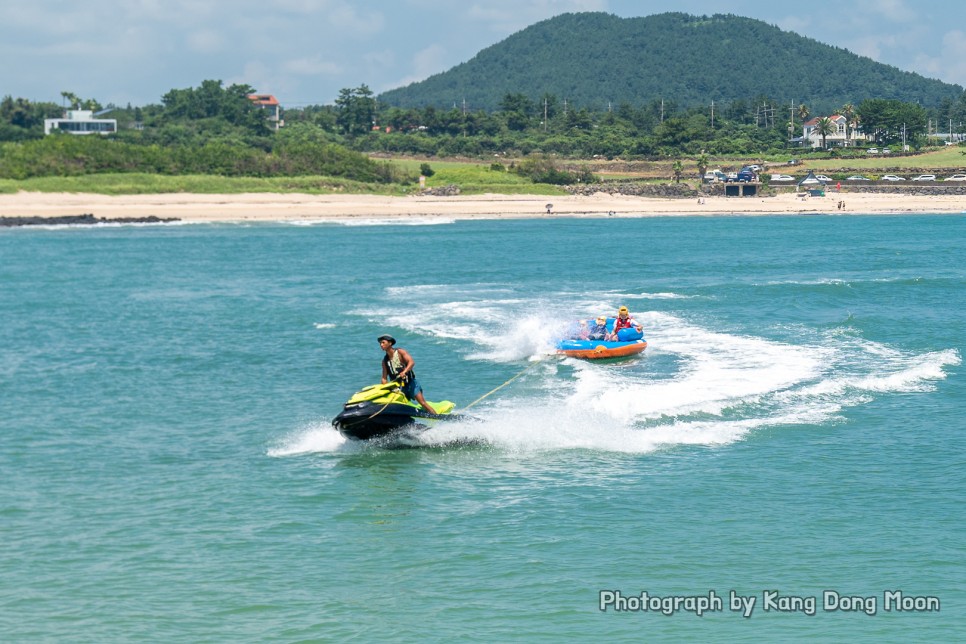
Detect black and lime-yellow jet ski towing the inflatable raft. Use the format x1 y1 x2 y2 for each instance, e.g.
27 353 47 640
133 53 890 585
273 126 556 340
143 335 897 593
332 381 463 440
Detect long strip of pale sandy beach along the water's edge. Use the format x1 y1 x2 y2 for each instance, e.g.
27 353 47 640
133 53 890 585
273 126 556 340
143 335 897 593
0 192 966 222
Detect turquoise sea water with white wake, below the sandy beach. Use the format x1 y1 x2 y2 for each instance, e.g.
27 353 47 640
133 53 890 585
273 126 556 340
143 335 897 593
0 215 966 642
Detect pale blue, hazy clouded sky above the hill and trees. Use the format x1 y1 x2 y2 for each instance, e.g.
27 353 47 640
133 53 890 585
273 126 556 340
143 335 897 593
0 0 966 107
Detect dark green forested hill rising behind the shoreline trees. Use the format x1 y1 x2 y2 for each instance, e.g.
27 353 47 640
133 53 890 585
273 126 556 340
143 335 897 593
379 13 963 113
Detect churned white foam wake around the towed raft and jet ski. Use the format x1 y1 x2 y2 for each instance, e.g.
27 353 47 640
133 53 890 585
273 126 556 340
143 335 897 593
298 284 961 453
